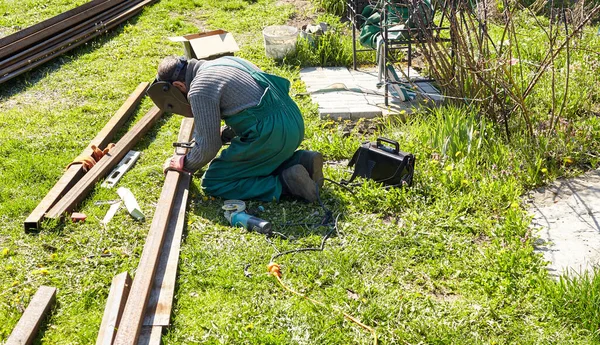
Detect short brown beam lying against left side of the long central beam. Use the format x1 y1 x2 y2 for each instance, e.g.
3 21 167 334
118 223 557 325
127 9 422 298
96 272 131 345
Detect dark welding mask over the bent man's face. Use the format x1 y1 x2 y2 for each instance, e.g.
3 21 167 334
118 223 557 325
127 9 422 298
146 58 194 117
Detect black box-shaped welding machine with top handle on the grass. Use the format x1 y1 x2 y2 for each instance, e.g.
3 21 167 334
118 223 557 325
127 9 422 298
344 137 415 186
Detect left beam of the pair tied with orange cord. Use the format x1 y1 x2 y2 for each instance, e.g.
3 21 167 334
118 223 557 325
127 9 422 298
24 82 148 231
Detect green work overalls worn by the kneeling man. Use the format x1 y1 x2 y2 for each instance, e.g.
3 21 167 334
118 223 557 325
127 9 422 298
201 57 304 201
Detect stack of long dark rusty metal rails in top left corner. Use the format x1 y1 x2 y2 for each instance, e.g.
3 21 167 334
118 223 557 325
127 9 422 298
0 0 157 84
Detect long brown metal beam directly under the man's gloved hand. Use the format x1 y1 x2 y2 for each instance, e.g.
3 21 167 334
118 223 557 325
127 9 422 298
114 119 194 345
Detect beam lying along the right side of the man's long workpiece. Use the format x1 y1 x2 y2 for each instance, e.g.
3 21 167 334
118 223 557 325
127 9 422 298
143 175 192 327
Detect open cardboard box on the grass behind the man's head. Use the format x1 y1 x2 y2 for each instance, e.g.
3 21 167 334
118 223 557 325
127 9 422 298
169 30 240 59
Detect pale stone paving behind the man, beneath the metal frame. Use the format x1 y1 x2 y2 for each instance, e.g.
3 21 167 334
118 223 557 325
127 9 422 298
300 67 443 120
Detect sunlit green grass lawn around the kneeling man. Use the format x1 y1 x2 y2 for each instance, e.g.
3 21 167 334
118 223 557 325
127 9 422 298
0 0 600 344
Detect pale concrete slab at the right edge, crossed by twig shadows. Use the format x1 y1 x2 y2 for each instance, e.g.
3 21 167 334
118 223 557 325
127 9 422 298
529 170 600 276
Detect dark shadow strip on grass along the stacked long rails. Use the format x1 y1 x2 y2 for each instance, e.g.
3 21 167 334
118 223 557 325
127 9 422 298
0 9 146 101
